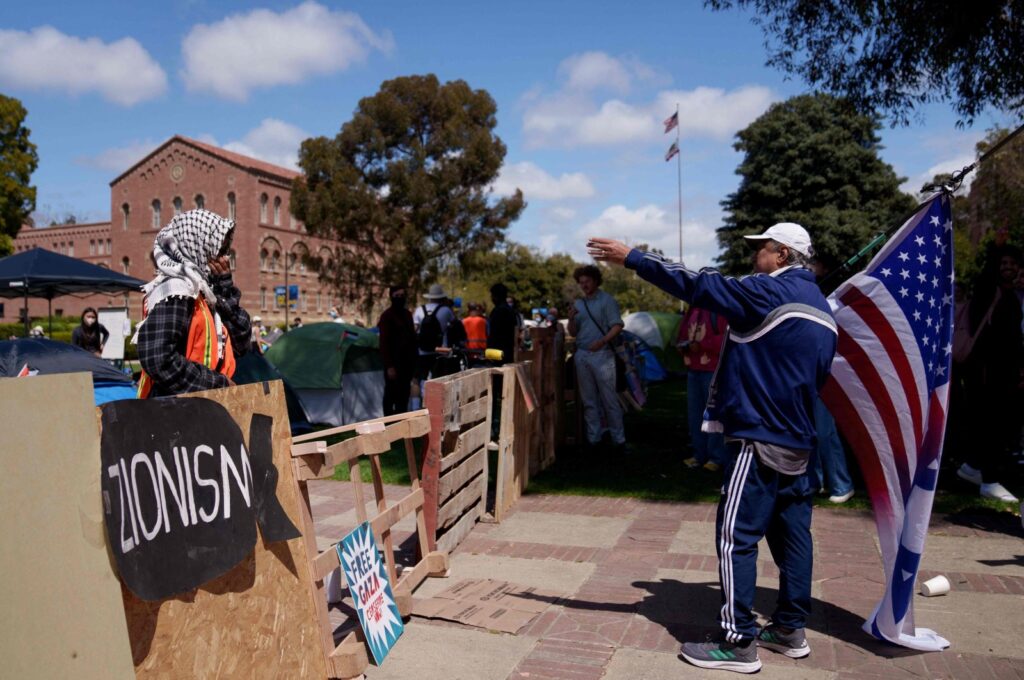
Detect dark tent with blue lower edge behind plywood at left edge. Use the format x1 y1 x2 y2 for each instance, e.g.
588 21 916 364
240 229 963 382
0 338 135 407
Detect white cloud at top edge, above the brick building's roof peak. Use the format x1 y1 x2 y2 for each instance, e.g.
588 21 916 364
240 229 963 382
181 1 393 101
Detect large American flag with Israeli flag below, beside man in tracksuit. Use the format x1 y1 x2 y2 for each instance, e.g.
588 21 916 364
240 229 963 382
821 194 953 650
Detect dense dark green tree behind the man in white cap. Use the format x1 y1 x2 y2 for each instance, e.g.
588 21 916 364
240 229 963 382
718 94 914 273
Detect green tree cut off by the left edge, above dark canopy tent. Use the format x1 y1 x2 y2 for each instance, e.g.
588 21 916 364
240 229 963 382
0 94 39 256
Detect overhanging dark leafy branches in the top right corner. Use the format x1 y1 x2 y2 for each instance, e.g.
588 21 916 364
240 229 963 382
705 0 1024 125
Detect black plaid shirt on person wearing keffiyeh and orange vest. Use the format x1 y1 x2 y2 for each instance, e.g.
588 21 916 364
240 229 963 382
138 273 252 396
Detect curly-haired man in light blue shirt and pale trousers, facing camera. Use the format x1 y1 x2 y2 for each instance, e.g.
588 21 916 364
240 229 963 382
569 264 626 448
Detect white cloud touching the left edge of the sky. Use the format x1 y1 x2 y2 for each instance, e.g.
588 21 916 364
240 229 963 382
0 26 167 107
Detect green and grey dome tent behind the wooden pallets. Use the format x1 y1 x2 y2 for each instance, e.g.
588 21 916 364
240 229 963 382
265 323 384 425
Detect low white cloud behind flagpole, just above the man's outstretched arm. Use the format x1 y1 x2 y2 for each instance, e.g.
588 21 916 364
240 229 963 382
567 204 719 268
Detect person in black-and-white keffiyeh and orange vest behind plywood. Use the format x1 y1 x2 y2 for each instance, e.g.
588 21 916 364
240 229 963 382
135 210 252 397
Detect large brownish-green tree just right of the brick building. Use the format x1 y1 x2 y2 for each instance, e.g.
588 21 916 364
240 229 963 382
291 75 525 313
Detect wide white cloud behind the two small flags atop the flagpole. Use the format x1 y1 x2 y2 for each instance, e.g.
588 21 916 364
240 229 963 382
522 52 775 147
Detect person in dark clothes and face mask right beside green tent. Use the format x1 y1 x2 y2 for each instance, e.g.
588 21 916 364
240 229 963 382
377 286 418 416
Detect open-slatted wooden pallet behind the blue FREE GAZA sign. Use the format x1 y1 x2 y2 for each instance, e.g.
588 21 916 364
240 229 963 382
292 411 449 678
